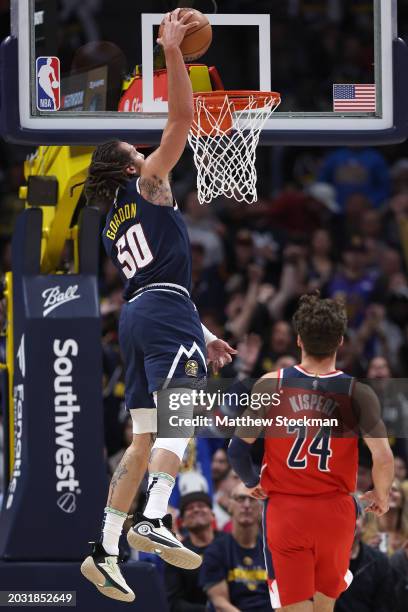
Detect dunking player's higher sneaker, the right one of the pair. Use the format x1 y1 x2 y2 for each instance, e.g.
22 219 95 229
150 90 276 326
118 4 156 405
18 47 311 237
127 512 202 569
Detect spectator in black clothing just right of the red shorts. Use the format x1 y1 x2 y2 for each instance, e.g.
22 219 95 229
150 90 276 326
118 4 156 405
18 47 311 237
334 516 395 612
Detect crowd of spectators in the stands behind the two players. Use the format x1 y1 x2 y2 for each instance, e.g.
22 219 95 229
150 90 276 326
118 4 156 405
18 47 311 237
0 137 408 612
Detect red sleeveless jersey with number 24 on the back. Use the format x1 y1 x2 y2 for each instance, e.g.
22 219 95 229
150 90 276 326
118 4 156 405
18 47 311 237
261 366 358 495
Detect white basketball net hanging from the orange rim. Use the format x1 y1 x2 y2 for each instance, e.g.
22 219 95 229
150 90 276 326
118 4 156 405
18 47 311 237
188 93 280 204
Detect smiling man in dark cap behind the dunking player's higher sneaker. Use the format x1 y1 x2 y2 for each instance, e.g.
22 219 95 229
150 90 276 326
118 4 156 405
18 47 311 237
164 491 219 612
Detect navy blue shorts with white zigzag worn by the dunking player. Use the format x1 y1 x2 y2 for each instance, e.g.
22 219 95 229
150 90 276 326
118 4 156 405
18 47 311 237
119 289 207 409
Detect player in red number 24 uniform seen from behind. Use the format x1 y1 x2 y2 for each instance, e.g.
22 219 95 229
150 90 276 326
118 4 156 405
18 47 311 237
229 295 394 612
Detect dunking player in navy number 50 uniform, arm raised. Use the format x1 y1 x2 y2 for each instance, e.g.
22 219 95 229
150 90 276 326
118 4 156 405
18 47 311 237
81 9 236 601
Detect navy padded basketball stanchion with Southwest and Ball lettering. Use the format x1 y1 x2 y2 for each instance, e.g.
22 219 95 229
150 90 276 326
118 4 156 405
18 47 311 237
0 207 167 612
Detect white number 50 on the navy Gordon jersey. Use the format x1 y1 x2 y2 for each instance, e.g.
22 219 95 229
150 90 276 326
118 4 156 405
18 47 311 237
116 223 153 278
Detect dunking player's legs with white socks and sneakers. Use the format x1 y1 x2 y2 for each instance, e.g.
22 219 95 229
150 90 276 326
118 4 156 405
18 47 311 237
81 384 201 601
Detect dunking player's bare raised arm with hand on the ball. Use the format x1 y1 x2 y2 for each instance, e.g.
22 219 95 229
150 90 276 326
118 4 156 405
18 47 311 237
140 9 197 191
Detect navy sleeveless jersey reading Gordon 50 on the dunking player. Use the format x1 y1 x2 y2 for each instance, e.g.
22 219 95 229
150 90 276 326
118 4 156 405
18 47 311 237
102 179 191 300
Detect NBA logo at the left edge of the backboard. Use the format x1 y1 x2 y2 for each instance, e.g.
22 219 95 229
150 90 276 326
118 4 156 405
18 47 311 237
36 56 61 111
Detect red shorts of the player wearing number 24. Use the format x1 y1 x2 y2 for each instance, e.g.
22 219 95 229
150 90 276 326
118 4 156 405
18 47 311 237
264 493 357 608
